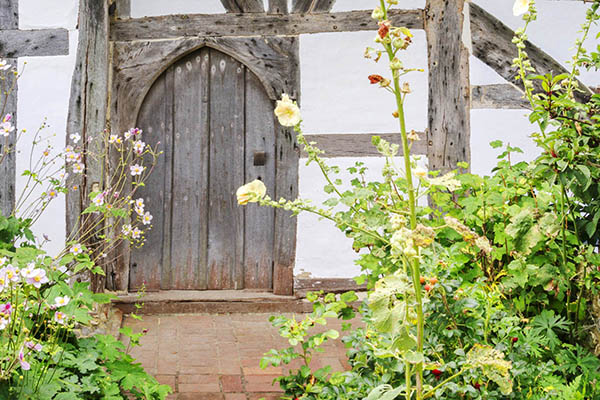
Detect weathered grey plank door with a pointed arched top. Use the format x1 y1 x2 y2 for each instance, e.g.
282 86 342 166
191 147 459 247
129 47 276 290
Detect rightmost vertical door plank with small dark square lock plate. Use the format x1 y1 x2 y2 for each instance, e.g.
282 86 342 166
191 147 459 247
244 71 275 290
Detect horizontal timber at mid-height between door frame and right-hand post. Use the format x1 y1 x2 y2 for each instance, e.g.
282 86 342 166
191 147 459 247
300 133 427 158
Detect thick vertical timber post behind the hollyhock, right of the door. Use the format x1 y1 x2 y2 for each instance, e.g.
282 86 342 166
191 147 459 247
425 0 471 171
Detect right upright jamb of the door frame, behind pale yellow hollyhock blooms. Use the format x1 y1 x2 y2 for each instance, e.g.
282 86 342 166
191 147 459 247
273 37 300 295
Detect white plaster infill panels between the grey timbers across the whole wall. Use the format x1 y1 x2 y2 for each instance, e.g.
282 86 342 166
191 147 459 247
9 0 600 284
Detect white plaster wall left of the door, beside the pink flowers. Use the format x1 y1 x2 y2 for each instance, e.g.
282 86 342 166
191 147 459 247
17 0 78 254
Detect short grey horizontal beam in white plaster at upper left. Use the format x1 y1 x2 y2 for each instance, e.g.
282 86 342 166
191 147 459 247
0 28 69 58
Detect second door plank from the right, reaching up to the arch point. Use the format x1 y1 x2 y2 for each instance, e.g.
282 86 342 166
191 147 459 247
208 50 245 289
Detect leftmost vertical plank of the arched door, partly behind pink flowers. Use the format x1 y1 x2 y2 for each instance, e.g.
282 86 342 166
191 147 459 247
129 74 171 291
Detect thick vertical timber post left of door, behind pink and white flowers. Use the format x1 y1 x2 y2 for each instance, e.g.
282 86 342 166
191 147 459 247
66 0 109 291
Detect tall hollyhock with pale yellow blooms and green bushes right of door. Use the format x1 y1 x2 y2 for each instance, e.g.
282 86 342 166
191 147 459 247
237 0 600 400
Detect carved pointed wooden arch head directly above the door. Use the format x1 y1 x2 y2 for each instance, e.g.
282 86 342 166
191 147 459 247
112 37 298 131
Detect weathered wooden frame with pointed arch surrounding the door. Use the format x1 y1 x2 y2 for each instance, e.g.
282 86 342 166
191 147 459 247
111 36 300 294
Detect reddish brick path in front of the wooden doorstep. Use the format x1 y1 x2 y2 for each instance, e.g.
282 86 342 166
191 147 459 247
123 314 354 400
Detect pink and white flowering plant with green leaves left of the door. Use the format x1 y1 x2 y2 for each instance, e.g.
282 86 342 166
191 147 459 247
0 60 171 400
